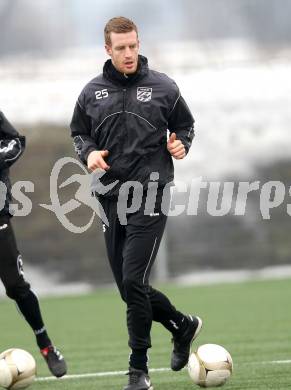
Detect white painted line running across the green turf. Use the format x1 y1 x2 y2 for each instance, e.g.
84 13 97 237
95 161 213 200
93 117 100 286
36 360 291 382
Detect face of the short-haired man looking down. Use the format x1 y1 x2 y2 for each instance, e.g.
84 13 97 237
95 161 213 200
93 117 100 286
105 31 139 74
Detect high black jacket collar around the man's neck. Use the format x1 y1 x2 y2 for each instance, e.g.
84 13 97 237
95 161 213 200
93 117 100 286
103 55 149 86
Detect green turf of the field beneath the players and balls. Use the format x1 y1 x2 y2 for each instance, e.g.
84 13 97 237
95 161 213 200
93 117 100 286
0 279 291 390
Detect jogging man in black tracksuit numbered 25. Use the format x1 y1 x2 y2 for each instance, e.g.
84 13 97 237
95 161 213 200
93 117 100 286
71 17 202 390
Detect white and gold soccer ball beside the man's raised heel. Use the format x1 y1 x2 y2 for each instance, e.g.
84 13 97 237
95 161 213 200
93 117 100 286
188 344 233 387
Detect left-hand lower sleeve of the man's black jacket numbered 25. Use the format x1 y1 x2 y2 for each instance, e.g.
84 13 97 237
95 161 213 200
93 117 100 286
70 98 98 165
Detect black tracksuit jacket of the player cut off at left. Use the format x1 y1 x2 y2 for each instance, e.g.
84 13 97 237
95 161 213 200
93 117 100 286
0 111 25 217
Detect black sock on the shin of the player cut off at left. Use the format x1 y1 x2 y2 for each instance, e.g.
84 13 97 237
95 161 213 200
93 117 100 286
15 290 51 349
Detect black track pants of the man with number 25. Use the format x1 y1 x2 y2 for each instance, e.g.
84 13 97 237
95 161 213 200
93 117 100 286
99 192 183 349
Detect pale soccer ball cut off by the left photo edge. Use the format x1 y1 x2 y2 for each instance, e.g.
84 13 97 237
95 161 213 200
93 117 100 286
0 348 36 390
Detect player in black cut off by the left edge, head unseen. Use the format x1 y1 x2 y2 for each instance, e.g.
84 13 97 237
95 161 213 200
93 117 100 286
0 111 67 377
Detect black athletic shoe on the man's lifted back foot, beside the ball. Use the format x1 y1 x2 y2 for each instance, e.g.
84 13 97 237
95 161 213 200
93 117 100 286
171 315 202 371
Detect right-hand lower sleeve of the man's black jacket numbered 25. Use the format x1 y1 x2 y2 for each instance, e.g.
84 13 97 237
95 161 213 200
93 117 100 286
168 92 195 154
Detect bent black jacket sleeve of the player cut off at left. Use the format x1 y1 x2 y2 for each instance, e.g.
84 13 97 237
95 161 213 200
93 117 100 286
0 112 25 170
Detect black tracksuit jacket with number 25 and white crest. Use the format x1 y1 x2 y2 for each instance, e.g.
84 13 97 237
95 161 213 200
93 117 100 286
71 55 194 196
